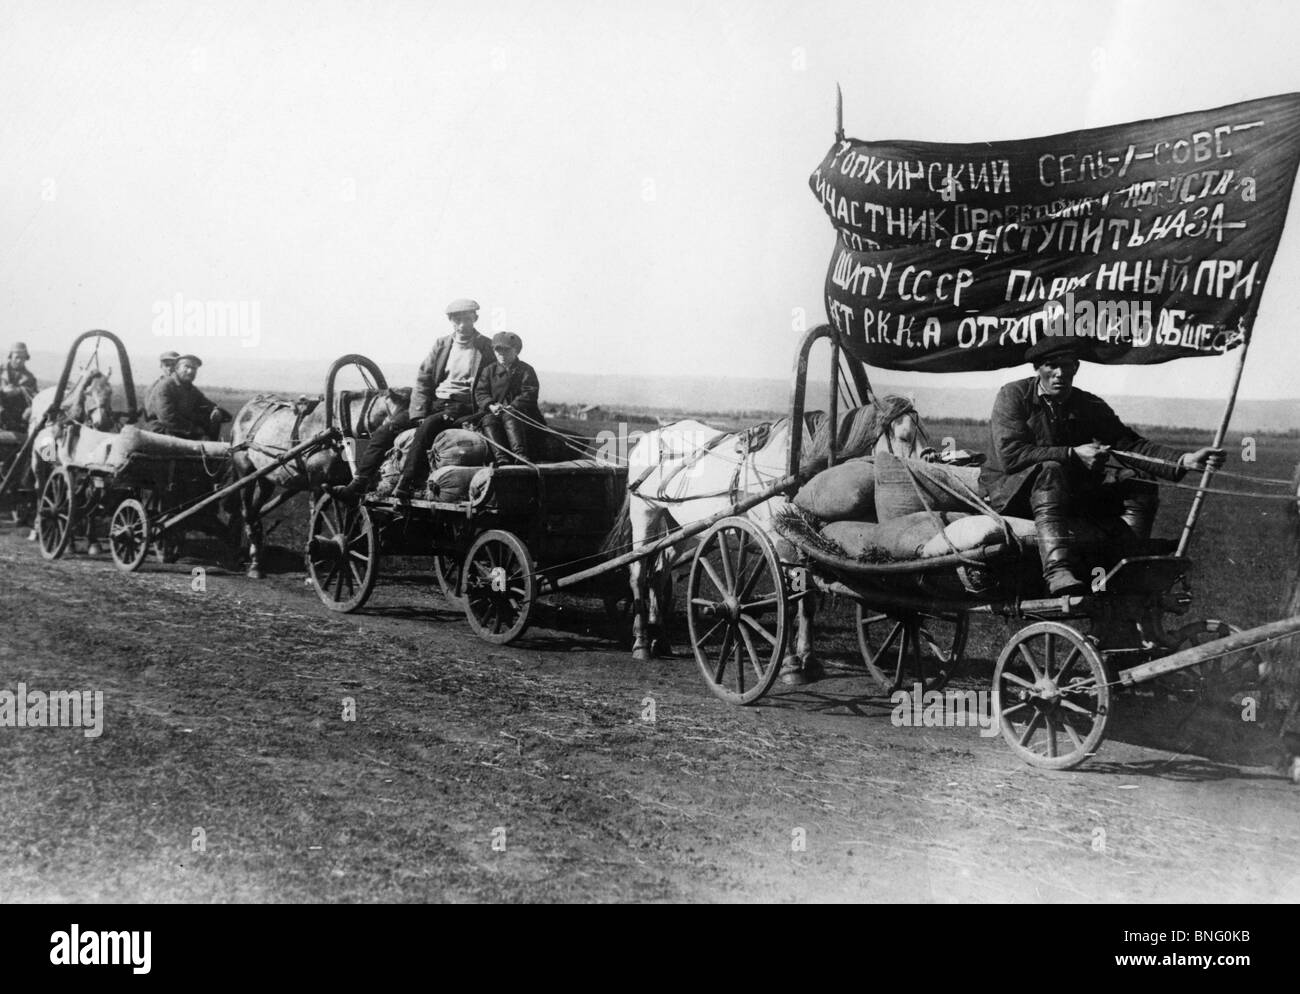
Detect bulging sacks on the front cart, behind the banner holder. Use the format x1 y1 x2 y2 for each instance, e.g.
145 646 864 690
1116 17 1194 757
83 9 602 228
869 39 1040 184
794 452 1036 561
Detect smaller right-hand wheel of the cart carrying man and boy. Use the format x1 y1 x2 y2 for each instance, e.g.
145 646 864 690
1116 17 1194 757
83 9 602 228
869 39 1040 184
464 529 537 646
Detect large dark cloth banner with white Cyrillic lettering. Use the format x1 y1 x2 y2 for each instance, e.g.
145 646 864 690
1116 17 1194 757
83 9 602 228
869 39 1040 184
810 94 1300 372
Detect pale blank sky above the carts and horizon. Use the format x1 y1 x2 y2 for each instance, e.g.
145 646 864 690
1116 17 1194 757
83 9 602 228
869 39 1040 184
0 0 1300 398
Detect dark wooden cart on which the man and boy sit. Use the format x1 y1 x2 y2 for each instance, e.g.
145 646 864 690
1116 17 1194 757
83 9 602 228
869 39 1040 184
307 357 627 643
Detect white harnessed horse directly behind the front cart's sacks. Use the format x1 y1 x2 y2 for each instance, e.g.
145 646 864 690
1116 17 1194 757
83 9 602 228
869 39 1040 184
605 396 927 682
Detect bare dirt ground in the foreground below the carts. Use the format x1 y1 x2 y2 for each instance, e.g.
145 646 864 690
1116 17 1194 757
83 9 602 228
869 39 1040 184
0 531 1300 902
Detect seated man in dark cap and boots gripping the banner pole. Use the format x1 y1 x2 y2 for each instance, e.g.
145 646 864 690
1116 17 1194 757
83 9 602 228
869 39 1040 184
980 335 1225 596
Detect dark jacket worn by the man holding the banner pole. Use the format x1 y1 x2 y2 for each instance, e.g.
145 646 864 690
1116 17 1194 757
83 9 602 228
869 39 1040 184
980 377 1186 511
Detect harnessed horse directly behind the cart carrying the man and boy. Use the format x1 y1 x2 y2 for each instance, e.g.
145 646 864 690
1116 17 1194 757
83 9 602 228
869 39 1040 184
230 389 411 580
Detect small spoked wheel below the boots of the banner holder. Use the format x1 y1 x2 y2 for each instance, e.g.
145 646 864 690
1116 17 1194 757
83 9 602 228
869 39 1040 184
993 621 1110 769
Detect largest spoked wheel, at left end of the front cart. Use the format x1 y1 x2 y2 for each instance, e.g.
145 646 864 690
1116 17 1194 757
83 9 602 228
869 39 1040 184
686 517 790 704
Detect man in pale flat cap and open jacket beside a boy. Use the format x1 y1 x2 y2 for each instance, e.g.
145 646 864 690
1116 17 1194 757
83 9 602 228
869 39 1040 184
330 291 497 504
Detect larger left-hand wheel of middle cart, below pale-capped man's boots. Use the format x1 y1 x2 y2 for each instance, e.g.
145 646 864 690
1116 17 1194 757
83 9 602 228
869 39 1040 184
307 494 380 613
